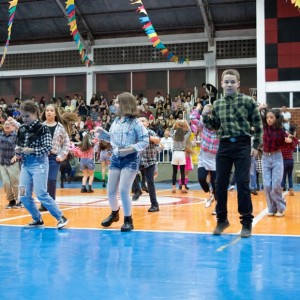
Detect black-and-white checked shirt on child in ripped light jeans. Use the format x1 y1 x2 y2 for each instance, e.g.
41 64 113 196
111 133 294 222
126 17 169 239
17 120 52 156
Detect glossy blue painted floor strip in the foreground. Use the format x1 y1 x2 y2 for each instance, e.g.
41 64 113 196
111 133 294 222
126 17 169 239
0 226 300 300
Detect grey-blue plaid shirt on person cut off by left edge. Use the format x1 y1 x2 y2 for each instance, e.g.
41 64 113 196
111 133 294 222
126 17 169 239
0 132 17 166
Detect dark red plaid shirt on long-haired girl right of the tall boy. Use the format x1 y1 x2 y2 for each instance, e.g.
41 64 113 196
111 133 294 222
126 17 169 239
263 125 288 152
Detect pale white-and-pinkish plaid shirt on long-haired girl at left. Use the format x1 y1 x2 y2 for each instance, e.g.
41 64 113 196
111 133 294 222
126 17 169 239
44 122 70 160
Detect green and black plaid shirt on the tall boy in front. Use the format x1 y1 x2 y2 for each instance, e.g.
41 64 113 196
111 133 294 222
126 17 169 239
203 93 262 149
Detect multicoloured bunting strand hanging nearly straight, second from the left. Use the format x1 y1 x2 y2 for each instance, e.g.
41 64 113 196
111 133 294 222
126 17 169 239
66 0 93 67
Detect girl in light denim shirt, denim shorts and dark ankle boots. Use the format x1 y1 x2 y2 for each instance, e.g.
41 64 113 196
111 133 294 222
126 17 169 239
97 93 149 232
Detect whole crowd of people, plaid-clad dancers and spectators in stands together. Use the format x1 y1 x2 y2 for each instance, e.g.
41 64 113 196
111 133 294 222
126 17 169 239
0 69 298 237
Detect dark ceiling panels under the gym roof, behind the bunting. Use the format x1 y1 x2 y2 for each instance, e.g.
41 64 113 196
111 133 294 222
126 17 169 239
0 0 256 47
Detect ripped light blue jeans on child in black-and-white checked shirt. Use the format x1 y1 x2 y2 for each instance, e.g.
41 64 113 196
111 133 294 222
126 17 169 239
19 156 63 221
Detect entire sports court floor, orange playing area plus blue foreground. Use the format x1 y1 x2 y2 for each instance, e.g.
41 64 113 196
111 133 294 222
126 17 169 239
0 184 300 300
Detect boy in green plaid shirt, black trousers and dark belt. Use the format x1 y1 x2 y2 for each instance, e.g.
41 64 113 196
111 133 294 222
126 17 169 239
202 69 262 237
